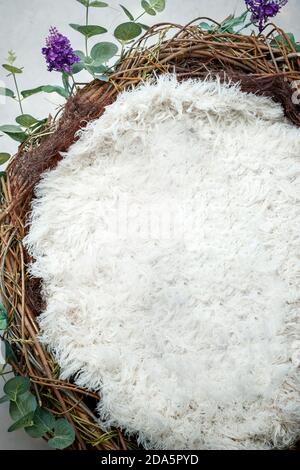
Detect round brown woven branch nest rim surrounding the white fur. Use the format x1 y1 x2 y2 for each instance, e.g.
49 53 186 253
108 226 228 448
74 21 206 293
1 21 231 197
0 23 300 450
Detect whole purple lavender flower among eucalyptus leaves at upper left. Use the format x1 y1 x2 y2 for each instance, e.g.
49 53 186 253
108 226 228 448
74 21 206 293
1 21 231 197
42 28 80 73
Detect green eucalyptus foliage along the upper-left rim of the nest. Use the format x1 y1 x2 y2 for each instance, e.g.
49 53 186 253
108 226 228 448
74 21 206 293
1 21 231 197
0 0 166 165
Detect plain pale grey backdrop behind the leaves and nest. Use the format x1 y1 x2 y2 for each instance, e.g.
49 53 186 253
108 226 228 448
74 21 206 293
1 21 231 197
0 0 300 450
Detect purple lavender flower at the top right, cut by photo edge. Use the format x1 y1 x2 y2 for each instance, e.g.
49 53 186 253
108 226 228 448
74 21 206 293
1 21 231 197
245 0 288 32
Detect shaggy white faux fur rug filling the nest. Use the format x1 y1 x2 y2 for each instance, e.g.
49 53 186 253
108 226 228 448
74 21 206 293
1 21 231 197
25 77 300 449
